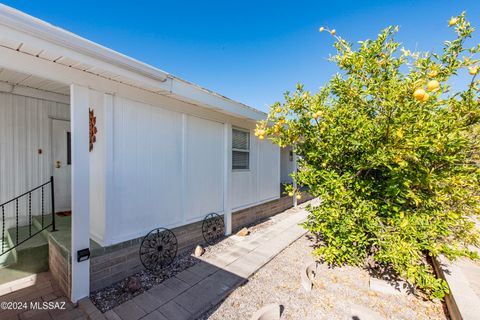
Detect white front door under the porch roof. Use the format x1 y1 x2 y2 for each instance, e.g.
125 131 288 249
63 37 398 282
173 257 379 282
52 119 72 212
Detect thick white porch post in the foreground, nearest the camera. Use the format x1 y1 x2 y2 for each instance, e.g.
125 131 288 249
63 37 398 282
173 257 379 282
70 84 90 302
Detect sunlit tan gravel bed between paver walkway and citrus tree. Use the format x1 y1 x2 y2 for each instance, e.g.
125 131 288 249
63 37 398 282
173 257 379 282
201 236 448 320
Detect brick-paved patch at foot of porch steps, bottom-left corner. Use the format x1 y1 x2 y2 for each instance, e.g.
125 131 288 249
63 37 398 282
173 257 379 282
0 272 87 320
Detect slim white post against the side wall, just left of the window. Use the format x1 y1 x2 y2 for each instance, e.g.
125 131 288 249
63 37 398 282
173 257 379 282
223 123 232 236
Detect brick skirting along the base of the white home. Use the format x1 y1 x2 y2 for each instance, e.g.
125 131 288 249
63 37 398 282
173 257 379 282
49 194 312 293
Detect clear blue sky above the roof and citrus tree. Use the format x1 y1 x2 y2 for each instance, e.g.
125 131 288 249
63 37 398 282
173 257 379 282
4 0 480 111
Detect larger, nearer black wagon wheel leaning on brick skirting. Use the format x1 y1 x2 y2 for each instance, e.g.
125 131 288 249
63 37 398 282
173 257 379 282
140 228 178 272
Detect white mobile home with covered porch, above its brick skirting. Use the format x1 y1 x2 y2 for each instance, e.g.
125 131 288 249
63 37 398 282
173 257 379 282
0 5 291 301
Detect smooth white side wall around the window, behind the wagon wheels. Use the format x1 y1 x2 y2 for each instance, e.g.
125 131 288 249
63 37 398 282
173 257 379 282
104 96 280 245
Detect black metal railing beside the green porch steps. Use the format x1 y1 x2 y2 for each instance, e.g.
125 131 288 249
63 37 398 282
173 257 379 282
0 177 56 256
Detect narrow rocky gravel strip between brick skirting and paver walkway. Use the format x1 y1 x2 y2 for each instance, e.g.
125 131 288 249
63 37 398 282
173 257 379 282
90 213 285 312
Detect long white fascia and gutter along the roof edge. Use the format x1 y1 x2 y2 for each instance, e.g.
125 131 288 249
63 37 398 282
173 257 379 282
0 4 266 120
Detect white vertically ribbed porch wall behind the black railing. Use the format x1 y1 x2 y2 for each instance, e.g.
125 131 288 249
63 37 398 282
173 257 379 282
0 92 70 228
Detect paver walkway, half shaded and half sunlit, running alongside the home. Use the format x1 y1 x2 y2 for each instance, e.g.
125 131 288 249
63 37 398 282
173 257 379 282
80 208 307 320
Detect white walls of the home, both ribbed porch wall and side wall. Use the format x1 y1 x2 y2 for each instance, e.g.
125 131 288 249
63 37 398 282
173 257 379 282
0 90 280 245
